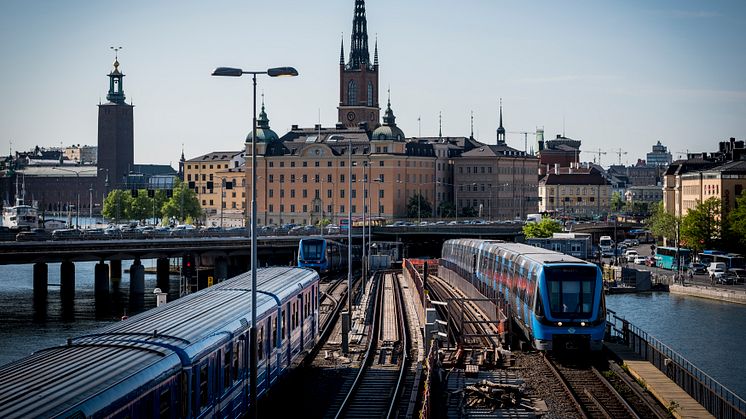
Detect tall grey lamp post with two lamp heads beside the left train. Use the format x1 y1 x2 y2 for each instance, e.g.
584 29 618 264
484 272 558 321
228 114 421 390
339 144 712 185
212 67 298 418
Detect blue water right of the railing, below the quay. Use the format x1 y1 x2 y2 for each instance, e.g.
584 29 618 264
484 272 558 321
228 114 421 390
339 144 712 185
606 293 746 399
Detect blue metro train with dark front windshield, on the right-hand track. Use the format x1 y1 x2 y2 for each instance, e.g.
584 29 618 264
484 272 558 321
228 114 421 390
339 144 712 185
441 239 606 351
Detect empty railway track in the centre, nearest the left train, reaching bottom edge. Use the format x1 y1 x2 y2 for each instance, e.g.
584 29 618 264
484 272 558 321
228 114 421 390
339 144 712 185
334 273 410 418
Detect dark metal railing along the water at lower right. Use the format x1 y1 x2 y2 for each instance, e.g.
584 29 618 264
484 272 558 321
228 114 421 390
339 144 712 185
607 310 746 418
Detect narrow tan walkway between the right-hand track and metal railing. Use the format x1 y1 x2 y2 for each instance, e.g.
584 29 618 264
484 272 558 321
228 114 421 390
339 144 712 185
605 343 714 418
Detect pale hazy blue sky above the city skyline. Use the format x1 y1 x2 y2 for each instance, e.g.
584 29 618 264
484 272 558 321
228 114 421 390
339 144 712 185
0 0 746 166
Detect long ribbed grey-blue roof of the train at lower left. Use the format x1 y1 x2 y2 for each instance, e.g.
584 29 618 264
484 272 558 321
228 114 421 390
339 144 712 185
0 267 318 418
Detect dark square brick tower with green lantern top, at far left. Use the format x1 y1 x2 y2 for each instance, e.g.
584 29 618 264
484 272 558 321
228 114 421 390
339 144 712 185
98 51 135 189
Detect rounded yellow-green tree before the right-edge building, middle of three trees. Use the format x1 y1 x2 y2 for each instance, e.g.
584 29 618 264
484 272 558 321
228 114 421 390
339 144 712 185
680 197 723 252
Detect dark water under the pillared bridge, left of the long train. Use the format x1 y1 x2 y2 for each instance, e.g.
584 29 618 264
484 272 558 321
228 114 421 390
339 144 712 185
0 260 179 365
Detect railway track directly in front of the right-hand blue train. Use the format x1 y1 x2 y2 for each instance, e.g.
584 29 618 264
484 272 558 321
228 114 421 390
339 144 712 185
544 356 640 419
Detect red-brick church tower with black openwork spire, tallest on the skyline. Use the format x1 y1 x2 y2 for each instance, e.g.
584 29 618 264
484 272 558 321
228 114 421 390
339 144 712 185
337 0 381 131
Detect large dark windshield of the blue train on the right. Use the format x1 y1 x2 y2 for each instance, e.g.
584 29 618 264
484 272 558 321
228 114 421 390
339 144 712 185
544 266 597 317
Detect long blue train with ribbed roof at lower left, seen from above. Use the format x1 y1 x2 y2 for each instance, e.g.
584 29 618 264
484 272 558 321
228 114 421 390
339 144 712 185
0 267 319 418
